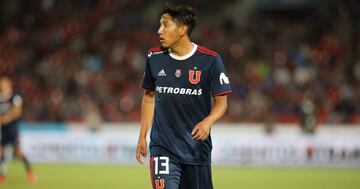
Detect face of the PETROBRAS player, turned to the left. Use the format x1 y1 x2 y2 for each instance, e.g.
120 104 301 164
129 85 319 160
158 13 184 48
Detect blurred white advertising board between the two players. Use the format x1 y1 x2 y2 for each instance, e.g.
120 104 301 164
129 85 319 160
21 124 137 164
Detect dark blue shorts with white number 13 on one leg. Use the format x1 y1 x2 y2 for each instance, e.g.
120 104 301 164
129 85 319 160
150 155 213 189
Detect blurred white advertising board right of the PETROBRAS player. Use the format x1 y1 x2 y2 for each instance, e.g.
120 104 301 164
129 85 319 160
213 127 360 166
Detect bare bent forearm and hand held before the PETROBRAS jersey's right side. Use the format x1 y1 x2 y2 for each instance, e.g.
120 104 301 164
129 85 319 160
191 95 227 141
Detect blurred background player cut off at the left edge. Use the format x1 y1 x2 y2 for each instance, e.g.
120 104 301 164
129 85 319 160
0 76 37 184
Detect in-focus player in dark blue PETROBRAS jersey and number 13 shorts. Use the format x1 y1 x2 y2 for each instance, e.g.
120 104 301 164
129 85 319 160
136 3 231 189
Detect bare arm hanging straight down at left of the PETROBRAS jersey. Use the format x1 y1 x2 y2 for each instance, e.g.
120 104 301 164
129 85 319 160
136 90 155 164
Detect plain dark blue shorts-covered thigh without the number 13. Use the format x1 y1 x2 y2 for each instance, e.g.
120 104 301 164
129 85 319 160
180 165 213 189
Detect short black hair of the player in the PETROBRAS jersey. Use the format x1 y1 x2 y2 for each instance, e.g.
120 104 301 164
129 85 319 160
159 1 196 36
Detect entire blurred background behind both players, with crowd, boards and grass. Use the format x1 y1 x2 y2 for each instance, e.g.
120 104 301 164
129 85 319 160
0 0 360 189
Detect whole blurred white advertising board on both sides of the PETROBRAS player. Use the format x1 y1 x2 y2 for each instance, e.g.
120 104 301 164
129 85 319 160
21 124 360 166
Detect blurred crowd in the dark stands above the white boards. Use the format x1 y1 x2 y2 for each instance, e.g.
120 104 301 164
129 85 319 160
0 0 360 124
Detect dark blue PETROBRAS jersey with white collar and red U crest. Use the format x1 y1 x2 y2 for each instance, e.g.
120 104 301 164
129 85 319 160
142 44 231 164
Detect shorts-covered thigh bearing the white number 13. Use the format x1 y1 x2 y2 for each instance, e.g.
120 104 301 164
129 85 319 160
150 155 181 189
